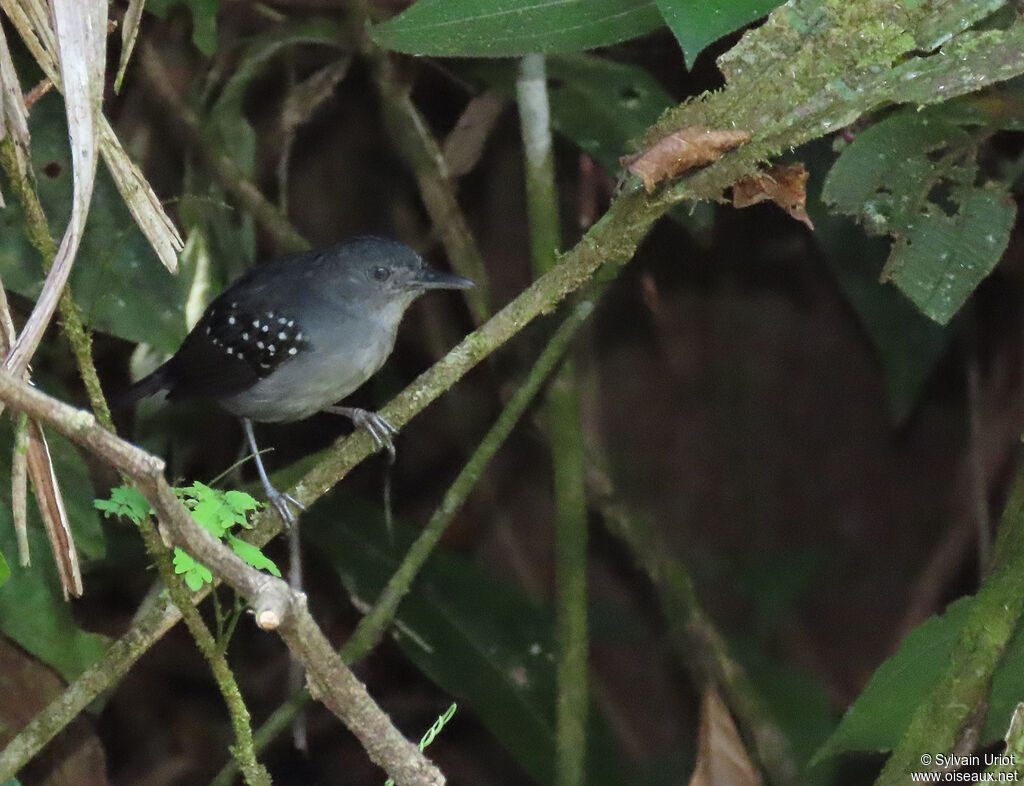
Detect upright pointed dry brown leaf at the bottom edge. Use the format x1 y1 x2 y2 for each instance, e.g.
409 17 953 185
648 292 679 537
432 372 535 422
689 688 761 786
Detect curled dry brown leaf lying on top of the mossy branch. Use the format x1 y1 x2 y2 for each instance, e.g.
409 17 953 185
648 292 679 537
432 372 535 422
620 126 751 193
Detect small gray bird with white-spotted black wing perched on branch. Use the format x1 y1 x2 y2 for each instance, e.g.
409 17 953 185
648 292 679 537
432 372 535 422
119 236 473 523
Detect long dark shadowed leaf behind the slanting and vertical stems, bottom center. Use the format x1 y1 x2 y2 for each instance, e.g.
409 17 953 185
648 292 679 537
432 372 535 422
302 499 626 786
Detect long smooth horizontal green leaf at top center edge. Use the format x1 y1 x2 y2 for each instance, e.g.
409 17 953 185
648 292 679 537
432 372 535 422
370 0 663 57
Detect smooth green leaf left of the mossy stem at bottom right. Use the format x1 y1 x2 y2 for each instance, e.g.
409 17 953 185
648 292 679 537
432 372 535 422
811 598 974 766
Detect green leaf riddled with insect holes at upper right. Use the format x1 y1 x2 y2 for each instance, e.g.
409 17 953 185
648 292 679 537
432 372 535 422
822 100 1017 324
